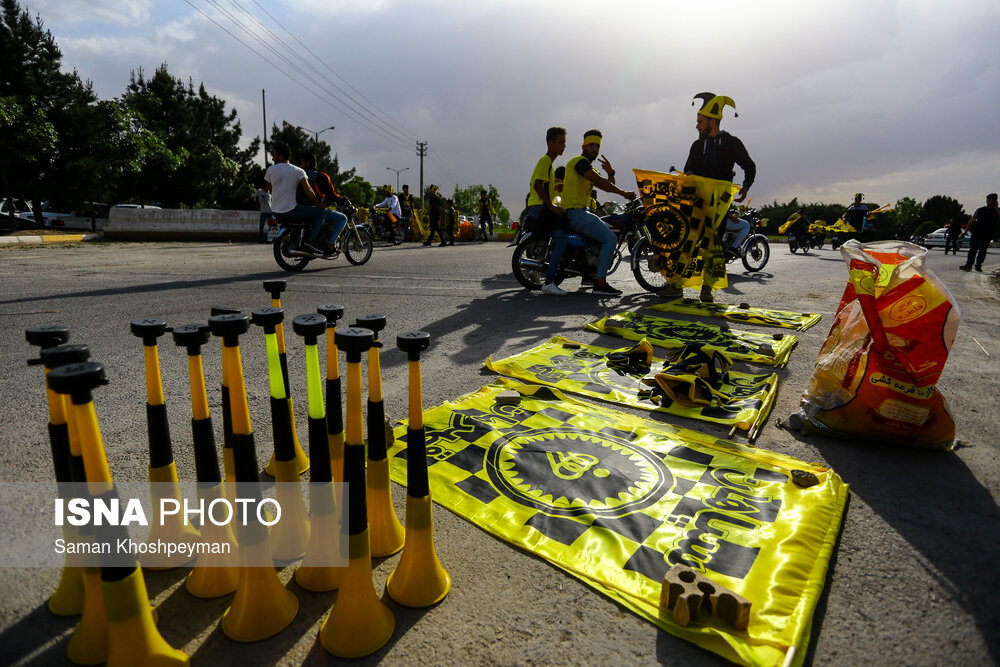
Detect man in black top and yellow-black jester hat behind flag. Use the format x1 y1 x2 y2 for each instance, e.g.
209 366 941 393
680 93 757 302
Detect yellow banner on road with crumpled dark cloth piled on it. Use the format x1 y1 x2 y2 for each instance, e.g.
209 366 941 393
485 336 778 430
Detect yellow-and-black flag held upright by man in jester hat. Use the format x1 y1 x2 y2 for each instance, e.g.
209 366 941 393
632 169 739 289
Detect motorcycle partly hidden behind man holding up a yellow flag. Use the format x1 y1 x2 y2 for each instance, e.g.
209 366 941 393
632 208 771 292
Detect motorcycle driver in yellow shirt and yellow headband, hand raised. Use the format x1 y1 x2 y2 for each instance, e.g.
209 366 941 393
562 130 635 296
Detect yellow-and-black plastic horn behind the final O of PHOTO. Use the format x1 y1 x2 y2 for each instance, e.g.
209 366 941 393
208 314 299 642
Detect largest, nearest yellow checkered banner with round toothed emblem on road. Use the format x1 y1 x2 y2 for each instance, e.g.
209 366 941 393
390 381 848 665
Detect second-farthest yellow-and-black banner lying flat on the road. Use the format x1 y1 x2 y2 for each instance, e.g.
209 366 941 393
584 311 799 366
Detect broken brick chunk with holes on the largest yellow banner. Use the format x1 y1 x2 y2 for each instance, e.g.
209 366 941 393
660 565 750 630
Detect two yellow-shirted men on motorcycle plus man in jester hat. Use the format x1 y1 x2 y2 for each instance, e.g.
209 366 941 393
526 93 757 301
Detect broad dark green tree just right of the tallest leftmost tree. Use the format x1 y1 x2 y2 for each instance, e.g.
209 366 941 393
122 64 260 209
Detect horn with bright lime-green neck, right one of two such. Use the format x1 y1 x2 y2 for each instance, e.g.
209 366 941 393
292 313 340 592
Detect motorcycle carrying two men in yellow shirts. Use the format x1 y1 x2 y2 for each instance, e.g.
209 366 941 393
510 200 643 290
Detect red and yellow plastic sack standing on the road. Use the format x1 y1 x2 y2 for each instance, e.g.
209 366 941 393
802 241 960 449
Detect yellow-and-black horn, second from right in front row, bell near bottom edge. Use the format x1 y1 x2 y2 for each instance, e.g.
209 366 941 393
319 328 396 658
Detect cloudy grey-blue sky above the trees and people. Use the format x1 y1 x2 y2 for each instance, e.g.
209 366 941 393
21 0 1000 214
